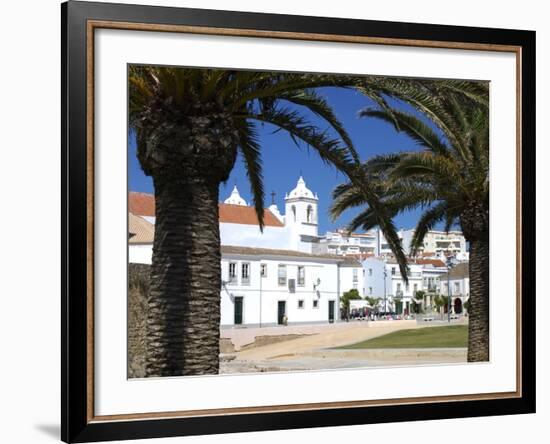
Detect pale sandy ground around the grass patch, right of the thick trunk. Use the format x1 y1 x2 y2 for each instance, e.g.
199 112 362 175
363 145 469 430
220 321 466 373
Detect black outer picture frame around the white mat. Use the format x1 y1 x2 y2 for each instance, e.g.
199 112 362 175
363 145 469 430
61 1 536 442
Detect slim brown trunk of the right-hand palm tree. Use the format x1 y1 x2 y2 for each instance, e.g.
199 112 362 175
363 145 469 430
468 236 489 362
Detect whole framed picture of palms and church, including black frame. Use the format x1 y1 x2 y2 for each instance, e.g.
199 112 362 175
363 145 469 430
61 1 536 442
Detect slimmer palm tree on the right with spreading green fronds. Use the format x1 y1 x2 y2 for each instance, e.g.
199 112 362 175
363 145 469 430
331 78 489 362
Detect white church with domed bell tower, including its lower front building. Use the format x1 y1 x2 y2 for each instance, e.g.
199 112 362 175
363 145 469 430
129 177 364 327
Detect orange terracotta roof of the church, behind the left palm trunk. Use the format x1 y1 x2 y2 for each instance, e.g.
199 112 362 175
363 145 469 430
128 191 284 227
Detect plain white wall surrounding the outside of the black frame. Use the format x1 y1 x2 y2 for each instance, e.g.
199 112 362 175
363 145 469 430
0 0 550 444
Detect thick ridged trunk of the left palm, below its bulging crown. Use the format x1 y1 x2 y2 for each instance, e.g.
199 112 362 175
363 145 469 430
146 175 221 376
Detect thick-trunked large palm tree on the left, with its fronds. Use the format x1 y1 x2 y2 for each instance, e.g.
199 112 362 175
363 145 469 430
129 66 357 376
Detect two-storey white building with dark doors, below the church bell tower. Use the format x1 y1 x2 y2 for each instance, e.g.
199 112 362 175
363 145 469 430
221 246 340 326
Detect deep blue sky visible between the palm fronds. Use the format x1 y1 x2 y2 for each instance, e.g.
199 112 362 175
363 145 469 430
128 84 444 234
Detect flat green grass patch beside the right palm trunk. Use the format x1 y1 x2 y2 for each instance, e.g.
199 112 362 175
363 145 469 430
339 325 468 349
